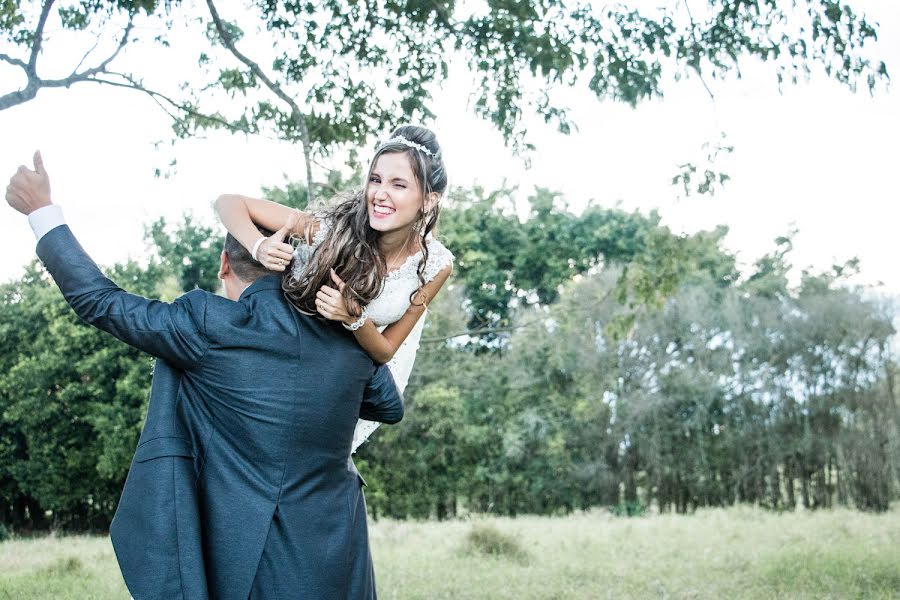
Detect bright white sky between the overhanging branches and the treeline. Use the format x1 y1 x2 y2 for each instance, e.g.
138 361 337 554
0 0 900 304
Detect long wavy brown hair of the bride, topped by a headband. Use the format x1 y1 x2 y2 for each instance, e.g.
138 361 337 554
281 125 447 316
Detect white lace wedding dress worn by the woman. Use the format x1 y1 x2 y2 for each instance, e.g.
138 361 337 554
292 221 454 452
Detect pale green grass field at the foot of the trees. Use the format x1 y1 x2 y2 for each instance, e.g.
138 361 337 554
0 506 900 600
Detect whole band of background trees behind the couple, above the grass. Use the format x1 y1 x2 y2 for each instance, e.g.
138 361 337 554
0 182 900 530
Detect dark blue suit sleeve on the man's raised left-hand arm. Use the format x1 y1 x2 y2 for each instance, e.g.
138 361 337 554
37 225 209 369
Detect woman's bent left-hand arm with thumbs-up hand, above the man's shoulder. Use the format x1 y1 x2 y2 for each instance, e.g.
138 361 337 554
213 194 313 270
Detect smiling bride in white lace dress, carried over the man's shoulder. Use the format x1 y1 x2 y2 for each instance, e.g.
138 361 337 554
215 125 453 452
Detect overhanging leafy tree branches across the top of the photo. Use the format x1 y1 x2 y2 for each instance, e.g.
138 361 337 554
0 0 887 192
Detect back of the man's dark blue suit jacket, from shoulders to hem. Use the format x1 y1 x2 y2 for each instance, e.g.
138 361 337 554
182 277 382 598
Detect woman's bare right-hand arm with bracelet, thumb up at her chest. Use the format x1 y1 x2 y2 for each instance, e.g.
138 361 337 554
316 264 453 364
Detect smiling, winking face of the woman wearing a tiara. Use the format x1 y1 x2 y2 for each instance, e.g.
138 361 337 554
366 152 423 233
